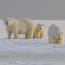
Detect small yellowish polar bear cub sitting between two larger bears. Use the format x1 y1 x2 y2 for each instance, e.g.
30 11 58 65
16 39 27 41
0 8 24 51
33 24 44 39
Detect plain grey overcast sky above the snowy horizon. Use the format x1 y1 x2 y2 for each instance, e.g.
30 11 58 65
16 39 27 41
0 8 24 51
0 0 65 20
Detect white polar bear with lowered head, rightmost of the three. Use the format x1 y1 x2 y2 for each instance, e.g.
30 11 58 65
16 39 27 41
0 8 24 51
48 24 64 44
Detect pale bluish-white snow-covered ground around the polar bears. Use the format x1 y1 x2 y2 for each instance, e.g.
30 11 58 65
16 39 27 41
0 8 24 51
0 20 65 65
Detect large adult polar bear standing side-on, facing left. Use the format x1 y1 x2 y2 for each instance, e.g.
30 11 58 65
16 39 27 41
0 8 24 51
4 18 35 39
